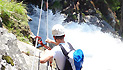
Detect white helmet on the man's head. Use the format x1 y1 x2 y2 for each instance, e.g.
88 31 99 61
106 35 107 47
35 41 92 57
52 24 65 36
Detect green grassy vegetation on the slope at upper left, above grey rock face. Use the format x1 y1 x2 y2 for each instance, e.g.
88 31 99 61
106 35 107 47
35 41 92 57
0 0 30 42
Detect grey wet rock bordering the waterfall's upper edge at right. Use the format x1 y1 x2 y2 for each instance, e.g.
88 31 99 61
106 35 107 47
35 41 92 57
84 15 116 34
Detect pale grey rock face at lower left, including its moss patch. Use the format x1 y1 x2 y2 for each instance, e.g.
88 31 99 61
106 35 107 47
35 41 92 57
0 28 46 70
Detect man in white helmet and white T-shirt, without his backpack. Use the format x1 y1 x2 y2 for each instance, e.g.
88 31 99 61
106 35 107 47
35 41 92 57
40 24 73 70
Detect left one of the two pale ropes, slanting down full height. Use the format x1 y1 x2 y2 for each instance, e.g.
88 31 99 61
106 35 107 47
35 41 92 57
32 0 43 70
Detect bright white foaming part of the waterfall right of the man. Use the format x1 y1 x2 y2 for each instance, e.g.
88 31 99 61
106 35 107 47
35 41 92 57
66 23 123 70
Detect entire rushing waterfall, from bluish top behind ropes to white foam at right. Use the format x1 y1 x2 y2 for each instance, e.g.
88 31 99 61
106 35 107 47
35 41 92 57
29 4 123 70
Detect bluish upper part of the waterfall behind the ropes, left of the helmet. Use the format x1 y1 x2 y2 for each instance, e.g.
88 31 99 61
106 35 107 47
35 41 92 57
29 5 65 42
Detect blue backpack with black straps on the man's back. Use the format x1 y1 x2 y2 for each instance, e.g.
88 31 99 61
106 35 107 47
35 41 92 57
58 42 84 70
